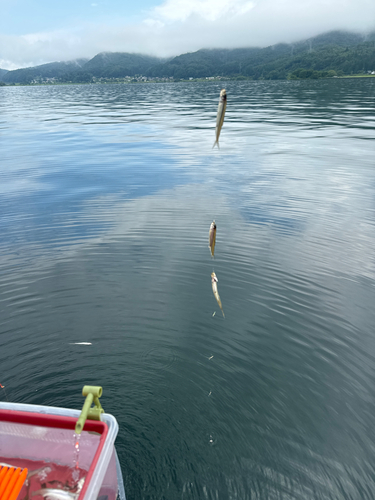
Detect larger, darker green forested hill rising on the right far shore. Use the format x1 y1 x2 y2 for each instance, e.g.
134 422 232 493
148 32 375 79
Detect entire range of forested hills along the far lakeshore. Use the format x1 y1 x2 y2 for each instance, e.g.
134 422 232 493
0 31 375 84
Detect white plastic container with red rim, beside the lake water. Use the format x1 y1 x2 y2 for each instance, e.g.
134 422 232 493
0 402 125 500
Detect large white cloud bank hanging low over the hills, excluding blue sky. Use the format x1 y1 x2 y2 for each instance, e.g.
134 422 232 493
0 0 375 69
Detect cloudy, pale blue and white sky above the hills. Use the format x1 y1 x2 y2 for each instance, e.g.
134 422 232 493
0 0 375 69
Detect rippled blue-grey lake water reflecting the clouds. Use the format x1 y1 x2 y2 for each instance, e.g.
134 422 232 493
0 79 375 500
